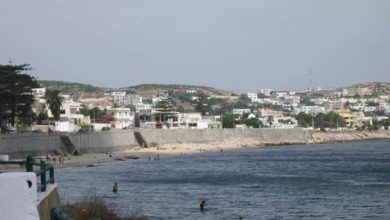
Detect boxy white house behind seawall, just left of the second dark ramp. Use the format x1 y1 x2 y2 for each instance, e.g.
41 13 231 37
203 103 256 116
107 108 134 129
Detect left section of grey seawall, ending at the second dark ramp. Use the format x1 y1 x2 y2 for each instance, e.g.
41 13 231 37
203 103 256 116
0 130 138 159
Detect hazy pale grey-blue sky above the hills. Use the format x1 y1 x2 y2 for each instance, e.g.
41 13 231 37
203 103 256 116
0 0 390 91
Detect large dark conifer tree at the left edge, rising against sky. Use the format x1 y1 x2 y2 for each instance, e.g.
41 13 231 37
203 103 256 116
0 64 39 130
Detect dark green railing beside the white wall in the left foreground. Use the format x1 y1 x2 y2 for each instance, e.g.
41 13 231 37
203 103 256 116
0 156 54 192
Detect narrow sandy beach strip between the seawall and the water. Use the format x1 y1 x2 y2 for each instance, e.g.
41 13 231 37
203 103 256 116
0 131 390 173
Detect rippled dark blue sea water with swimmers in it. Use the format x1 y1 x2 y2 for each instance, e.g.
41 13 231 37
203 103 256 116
56 140 390 219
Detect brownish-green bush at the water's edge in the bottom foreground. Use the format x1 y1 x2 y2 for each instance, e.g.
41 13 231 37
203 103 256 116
62 195 149 220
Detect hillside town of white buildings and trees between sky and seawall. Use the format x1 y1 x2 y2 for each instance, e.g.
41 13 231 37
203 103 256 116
2 64 390 133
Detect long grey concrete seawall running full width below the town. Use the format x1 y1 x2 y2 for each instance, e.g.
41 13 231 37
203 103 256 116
0 128 390 159
